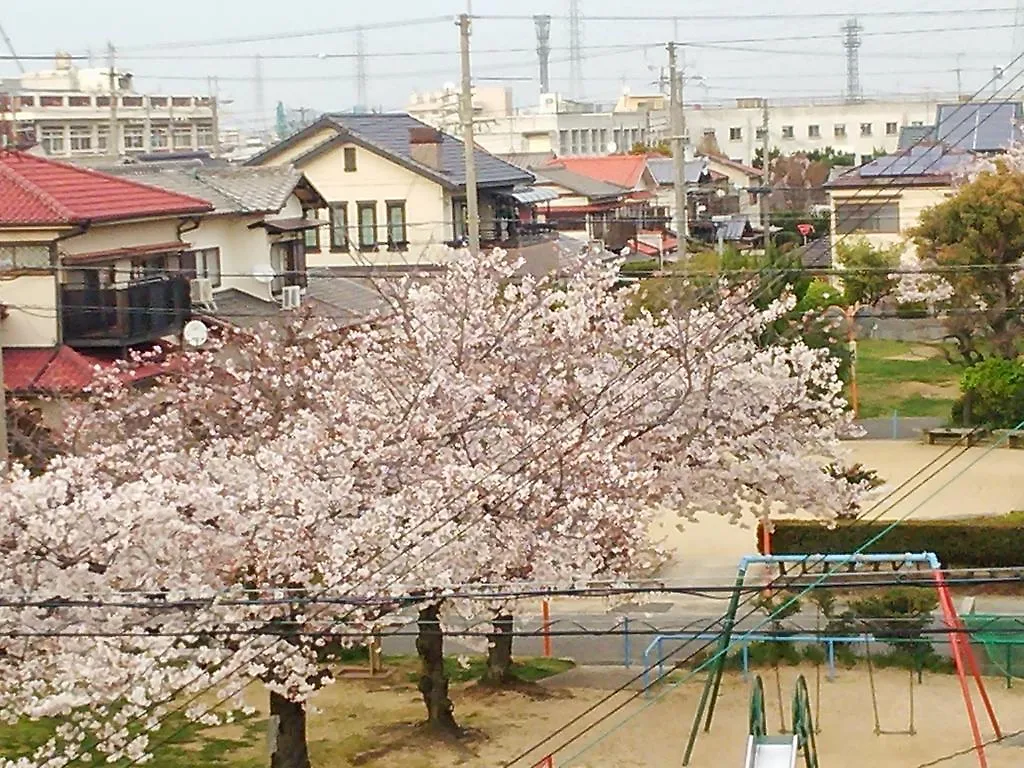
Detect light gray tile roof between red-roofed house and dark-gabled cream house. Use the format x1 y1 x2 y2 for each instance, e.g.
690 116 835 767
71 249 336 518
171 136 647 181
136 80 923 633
108 165 302 213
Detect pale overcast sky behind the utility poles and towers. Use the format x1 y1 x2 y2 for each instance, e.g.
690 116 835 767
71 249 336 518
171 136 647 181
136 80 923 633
0 0 1024 129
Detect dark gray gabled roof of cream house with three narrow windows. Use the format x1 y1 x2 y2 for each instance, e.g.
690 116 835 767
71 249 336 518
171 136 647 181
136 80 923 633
256 113 534 188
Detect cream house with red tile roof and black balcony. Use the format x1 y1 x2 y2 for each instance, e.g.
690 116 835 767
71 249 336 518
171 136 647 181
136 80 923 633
0 151 213 350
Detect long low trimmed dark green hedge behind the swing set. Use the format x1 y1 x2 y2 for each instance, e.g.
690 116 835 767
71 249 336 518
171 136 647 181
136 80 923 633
757 512 1024 568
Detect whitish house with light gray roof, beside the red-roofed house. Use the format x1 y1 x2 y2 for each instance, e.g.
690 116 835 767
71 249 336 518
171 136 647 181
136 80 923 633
101 163 327 314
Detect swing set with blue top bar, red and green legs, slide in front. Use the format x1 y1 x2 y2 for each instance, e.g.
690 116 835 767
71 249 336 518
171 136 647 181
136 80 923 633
683 552 1002 768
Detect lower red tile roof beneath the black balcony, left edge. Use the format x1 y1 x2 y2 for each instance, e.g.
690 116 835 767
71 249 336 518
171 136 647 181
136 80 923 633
3 346 172 394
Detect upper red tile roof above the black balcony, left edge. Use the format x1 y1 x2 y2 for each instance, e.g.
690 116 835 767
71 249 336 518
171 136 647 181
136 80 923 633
0 151 213 226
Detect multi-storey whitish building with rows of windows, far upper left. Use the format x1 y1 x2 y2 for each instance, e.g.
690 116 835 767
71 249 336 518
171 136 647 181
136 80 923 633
0 54 217 158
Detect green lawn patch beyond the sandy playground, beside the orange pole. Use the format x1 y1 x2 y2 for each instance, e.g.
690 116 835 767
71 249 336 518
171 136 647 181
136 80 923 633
857 339 963 419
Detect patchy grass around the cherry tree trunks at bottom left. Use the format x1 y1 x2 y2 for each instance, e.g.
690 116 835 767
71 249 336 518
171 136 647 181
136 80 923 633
0 656 574 768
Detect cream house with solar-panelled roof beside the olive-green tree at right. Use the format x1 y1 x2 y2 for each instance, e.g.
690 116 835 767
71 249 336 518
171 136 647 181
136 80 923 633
825 146 975 260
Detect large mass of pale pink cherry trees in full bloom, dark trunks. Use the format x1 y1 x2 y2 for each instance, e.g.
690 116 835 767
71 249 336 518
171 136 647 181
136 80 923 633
0 252 865 768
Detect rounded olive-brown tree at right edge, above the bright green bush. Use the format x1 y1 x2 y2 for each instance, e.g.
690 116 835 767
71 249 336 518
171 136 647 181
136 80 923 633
897 156 1024 366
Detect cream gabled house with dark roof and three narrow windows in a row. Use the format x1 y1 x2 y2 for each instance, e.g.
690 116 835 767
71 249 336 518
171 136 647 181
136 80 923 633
247 114 534 266
